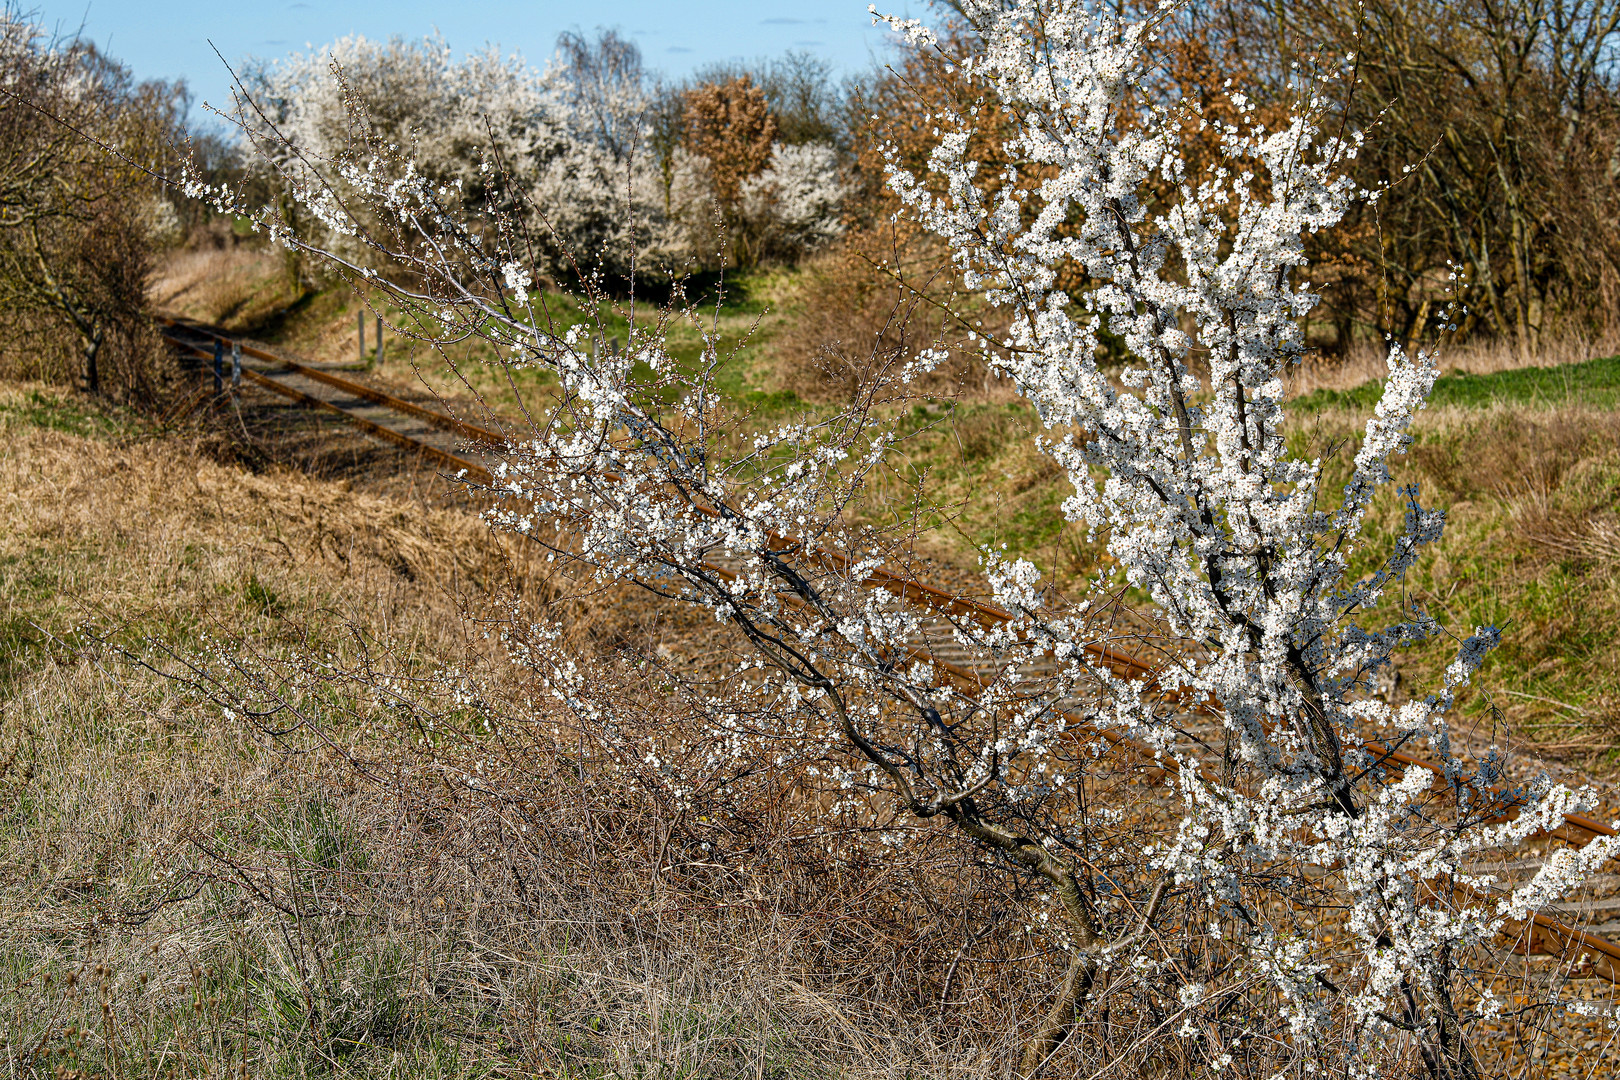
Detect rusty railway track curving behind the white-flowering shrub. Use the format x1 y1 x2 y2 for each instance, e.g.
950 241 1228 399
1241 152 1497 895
162 319 1620 983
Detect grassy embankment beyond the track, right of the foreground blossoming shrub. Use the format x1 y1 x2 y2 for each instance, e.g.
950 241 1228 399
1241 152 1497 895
1296 358 1620 757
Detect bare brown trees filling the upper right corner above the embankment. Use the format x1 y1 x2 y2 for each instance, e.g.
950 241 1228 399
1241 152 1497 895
1200 0 1620 355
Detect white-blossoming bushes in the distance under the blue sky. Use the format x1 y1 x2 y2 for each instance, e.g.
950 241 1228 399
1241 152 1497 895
237 36 844 275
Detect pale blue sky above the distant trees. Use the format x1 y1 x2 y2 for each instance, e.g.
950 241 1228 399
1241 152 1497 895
24 0 925 123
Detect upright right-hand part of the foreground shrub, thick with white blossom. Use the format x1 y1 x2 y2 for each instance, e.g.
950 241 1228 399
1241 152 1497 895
868 0 1615 1075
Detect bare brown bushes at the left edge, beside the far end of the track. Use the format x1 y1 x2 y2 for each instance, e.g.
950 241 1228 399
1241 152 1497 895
0 15 180 402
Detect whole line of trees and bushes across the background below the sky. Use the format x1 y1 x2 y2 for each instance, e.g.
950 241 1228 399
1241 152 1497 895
0 0 1620 397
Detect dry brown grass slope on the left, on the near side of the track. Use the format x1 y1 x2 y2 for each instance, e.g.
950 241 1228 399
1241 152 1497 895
0 387 1036 1077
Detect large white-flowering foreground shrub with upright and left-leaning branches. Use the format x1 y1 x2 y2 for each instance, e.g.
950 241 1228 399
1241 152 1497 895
183 0 1614 1077
